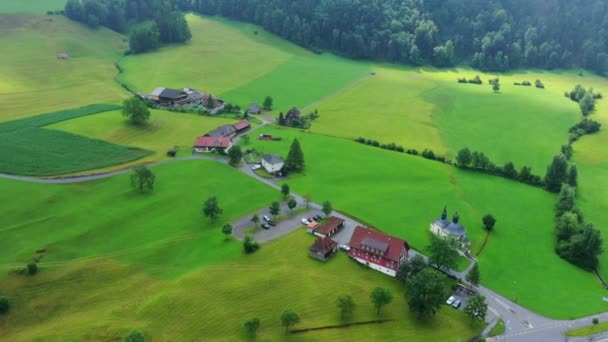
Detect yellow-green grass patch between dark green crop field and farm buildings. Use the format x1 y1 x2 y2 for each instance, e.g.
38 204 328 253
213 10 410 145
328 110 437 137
49 110 240 167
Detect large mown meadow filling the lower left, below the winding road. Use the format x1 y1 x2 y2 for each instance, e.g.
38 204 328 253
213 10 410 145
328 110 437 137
0 160 481 341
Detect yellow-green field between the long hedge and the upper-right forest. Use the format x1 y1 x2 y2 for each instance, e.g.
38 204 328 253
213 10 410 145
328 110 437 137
311 66 579 174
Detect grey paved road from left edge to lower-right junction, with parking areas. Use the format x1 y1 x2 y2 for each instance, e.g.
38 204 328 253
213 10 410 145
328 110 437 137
0 145 608 342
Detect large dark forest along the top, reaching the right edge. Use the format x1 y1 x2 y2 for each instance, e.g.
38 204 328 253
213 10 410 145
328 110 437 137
172 0 608 75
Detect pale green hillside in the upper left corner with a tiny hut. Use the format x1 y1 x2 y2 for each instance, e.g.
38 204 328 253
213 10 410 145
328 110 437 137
0 14 126 121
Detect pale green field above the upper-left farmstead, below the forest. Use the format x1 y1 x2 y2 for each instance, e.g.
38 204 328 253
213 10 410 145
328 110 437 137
116 15 369 111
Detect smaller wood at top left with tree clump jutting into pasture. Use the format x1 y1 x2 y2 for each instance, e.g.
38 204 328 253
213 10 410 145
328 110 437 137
64 0 192 53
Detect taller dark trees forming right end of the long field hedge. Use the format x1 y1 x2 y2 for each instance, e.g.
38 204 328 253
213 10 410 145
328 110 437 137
456 147 543 186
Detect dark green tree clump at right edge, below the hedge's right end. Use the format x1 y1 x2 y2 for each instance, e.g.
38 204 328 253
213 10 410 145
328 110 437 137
555 184 603 271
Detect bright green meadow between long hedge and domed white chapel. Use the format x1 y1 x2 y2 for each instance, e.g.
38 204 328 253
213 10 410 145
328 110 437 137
242 128 606 318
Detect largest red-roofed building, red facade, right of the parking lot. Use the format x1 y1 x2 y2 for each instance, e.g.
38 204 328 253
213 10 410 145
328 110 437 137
348 226 410 277
